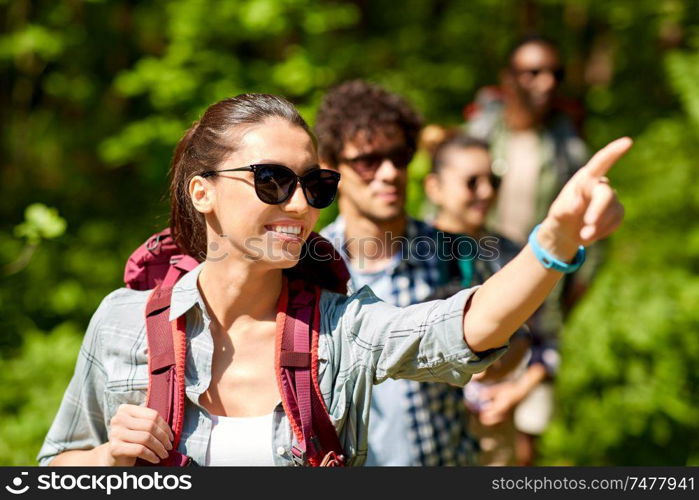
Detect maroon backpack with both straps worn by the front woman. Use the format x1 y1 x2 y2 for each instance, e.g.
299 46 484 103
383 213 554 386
124 229 349 466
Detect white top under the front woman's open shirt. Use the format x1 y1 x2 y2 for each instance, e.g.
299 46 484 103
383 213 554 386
206 413 274 466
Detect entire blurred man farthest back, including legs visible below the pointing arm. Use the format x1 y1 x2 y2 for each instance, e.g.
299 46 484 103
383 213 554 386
465 36 599 465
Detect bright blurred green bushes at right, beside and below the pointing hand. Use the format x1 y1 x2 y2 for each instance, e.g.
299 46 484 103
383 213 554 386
543 45 699 465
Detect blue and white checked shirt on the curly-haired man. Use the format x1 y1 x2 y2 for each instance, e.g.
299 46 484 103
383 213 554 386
321 216 476 466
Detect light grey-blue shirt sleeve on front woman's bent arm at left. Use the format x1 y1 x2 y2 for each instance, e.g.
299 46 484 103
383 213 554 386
37 294 112 465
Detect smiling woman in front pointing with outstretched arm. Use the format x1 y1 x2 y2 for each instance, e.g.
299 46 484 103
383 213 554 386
38 94 630 465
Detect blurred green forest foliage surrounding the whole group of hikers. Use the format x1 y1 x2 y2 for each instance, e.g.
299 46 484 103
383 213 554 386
0 0 699 464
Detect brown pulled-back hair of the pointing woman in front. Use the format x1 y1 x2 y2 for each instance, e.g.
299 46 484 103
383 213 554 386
170 94 315 261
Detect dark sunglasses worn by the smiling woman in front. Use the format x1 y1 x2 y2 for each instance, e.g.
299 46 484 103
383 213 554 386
200 163 340 208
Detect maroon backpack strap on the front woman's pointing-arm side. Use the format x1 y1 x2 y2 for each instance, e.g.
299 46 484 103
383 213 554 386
275 279 345 467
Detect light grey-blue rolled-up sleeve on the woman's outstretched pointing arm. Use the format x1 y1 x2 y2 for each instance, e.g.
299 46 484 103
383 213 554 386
328 287 507 385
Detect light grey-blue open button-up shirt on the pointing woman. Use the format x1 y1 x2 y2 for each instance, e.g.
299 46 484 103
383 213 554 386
37 264 505 465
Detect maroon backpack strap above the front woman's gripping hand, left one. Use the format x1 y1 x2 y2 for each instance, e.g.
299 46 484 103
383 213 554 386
136 284 191 466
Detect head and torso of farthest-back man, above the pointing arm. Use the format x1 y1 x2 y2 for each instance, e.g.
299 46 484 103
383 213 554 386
466 37 588 244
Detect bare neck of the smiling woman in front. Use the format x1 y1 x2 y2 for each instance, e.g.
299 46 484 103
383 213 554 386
198 258 282 331
